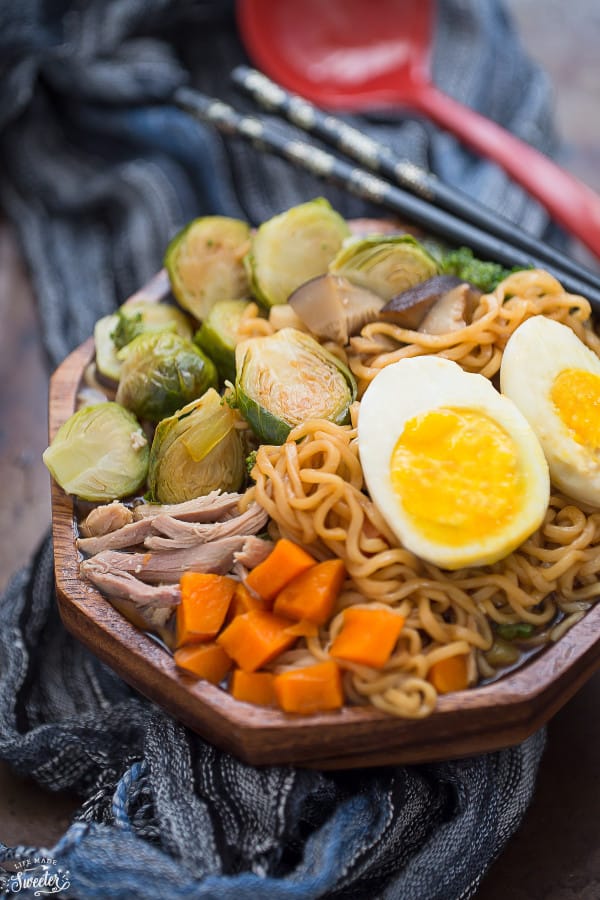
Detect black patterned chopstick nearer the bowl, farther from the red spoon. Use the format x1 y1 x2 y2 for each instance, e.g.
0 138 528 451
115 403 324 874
173 87 600 314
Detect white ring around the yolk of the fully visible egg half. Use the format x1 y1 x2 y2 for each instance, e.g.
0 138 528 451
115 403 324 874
358 356 550 569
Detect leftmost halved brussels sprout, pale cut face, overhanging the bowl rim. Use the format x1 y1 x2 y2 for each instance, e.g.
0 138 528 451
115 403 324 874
42 402 149 501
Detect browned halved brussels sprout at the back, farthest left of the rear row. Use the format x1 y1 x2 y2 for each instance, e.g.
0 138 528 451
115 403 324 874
165 216 250 320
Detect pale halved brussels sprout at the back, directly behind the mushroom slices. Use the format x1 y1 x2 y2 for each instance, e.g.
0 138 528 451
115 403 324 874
246 197 350 307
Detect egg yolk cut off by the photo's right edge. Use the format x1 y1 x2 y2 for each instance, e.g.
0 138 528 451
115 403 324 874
550 369 600 447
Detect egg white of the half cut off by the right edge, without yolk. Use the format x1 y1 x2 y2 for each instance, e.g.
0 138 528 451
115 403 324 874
500 316 600 506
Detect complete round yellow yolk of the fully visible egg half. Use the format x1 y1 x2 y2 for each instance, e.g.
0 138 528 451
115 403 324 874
390 407 524 547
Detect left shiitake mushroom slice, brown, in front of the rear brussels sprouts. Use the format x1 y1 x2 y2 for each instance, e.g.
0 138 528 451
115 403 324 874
288 275 385 344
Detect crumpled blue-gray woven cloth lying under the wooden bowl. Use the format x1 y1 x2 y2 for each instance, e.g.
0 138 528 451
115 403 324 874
0 0 558 900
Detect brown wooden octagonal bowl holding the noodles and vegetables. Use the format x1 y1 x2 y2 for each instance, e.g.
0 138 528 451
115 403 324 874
49 272 600 769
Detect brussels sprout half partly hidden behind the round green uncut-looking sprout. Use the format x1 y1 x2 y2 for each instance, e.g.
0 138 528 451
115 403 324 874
94 300 193 381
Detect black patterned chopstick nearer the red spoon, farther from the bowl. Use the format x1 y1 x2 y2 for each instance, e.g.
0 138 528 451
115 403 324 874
231 66 600 290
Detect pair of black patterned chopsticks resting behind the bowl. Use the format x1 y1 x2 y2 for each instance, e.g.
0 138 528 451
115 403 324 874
174 66 600 313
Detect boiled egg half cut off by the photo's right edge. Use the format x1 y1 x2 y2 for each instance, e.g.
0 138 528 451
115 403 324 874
500 316 600 506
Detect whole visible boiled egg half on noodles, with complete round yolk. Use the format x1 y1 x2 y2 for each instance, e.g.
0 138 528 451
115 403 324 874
358 356 550 569
